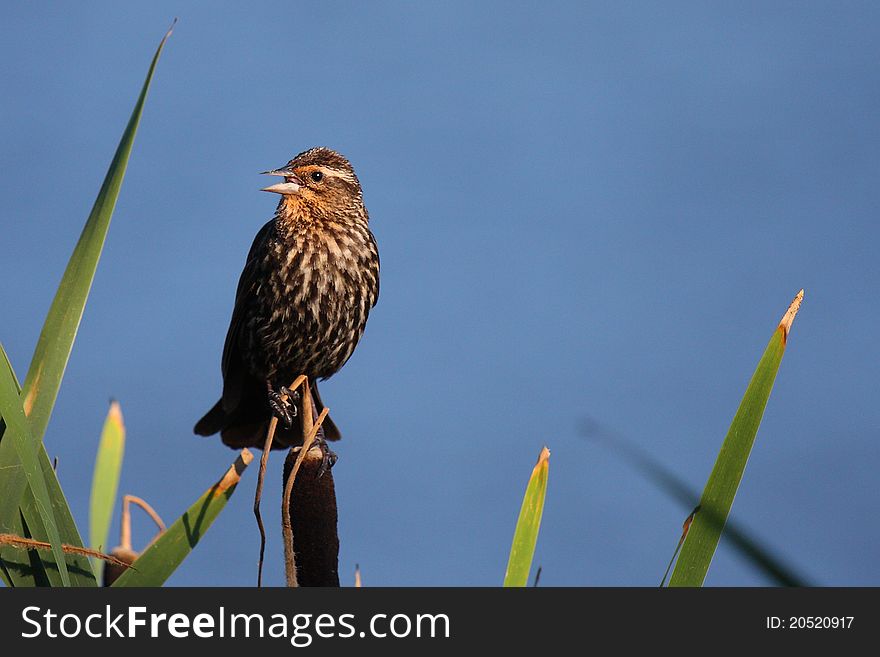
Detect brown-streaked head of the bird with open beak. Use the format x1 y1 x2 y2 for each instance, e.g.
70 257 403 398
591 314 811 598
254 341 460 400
262 147 363 218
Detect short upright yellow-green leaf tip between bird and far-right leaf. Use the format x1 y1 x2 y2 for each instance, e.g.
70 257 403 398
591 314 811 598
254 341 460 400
504 447 550 586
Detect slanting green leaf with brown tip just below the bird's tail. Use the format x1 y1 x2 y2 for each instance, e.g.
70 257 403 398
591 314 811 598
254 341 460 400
112 449 254 586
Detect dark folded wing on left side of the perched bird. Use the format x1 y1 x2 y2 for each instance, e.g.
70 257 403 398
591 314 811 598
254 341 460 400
221 220 275 412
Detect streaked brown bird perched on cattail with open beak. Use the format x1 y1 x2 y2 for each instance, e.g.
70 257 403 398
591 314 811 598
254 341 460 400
195 148 379 465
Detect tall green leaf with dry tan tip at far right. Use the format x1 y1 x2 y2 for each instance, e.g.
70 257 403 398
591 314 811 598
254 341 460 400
669 290 804 586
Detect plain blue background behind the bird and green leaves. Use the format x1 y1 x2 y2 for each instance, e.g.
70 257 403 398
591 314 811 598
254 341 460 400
0 2 880 586
